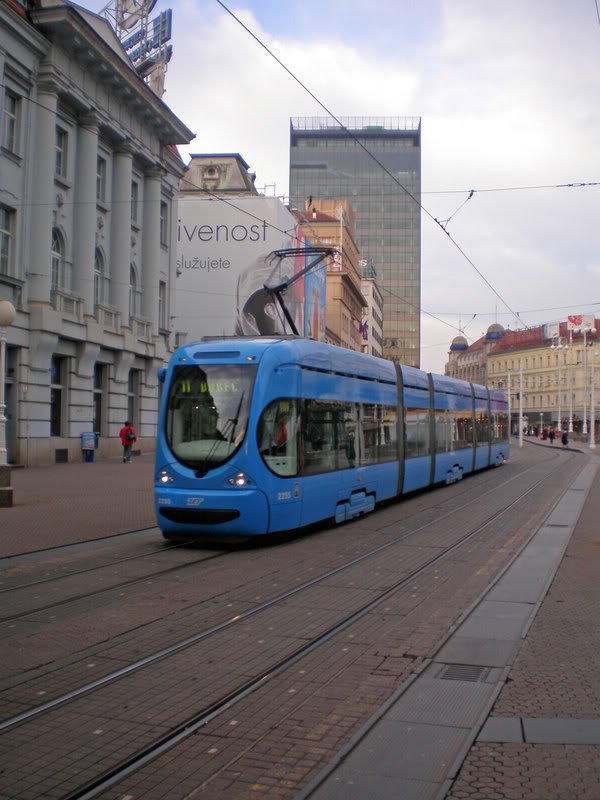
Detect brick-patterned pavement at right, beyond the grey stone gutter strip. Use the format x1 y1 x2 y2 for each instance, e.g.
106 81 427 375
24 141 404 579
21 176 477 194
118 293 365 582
447 456 600 800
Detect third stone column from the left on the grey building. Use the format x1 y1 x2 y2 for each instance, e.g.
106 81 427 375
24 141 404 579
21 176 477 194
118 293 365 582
110 143 133 327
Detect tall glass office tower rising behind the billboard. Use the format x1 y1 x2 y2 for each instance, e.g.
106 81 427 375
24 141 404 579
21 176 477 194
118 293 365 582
290 117 421 367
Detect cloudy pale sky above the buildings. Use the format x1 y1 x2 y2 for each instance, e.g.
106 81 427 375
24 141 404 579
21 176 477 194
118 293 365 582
85 0 600 373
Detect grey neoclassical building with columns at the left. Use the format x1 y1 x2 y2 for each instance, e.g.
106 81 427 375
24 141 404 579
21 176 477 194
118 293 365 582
0 0 193 465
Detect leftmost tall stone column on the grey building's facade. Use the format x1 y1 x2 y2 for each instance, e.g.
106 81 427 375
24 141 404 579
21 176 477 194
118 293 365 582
27 83 57 303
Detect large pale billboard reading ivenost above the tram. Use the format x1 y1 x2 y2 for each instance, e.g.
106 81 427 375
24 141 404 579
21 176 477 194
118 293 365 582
173 195 326 342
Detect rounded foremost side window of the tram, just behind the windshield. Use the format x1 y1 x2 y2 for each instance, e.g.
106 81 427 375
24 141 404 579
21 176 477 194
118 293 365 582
256 398 300 477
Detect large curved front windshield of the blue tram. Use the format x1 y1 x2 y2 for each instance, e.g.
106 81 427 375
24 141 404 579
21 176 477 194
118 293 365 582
165 364 257 475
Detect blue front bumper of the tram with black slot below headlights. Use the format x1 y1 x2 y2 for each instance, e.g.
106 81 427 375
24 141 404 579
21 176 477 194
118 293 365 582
155 487 269 536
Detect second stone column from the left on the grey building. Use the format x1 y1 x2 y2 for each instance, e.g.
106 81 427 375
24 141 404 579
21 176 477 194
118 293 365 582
73 114 98 315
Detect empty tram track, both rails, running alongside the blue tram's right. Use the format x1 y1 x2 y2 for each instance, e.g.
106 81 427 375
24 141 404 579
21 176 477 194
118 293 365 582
0 454 576 799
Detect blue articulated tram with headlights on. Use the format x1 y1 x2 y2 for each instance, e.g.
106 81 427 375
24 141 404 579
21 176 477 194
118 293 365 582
155 336 509 538
